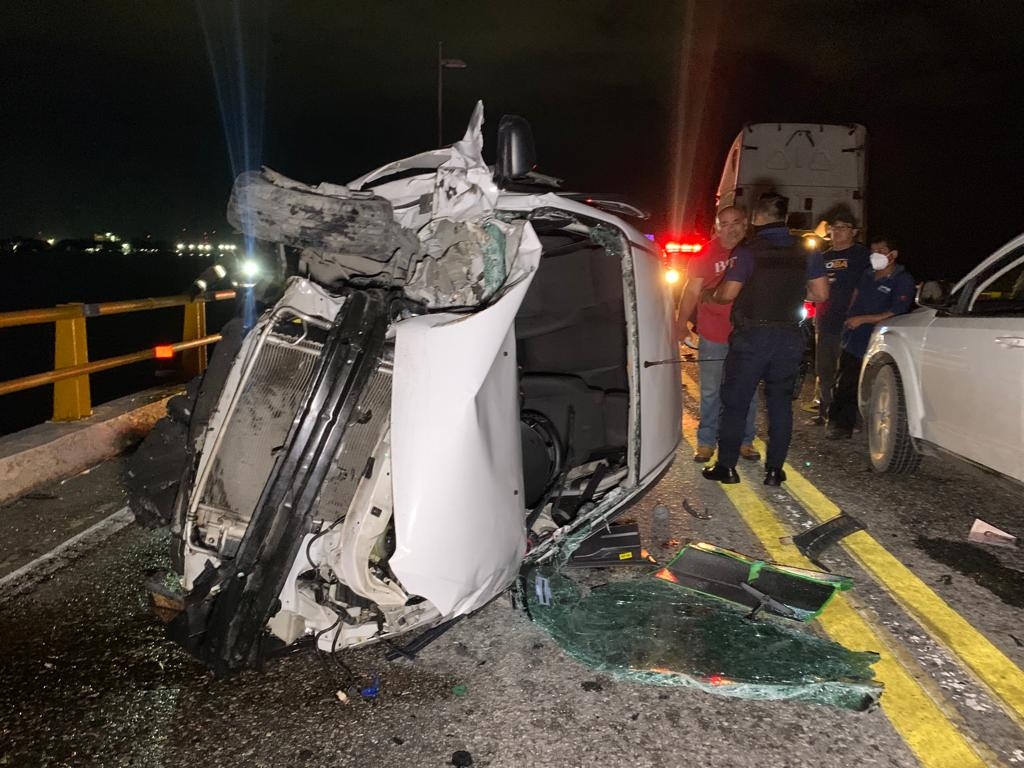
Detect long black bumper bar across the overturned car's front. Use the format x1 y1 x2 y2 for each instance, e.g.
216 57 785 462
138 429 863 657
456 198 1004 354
168 291 390 677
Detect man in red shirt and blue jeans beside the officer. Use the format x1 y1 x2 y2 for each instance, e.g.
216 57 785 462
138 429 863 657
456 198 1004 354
679 206 761 463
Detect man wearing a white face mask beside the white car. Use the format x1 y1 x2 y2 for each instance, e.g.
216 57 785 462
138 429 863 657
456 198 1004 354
825 236 914 440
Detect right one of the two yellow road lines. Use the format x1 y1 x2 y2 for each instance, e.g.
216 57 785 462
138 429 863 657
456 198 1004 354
757 440 1024 725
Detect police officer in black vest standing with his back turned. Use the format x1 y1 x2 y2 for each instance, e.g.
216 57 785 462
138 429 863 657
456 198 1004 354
702 195 828 485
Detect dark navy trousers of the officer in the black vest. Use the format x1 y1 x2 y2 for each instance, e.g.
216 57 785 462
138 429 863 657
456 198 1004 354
718 326 804 468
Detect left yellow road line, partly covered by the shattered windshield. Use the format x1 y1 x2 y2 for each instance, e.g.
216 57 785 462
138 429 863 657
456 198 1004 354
683 416 987 768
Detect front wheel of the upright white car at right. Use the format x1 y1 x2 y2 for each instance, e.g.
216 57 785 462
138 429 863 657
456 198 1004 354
866 362 921 474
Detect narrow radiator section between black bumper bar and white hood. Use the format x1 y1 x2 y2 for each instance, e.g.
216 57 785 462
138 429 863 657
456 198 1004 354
316 364 391 521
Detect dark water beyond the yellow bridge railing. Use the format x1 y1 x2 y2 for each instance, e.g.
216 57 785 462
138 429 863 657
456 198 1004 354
0 251 234 434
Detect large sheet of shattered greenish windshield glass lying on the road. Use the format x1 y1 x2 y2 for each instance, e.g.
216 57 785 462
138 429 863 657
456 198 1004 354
525 569 882 710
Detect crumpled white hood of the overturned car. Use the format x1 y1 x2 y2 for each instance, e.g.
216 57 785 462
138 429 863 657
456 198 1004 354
390 227 541 615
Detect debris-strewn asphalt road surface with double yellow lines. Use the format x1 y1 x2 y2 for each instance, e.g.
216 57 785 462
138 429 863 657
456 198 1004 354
0 367 1024 768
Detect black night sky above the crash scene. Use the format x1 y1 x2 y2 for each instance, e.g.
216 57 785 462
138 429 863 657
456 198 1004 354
0 0 1024 278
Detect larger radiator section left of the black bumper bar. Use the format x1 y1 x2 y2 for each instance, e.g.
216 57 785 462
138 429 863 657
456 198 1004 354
202 334 321 521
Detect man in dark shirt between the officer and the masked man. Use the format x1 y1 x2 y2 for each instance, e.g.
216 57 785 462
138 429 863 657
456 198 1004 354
812 208 868 426
